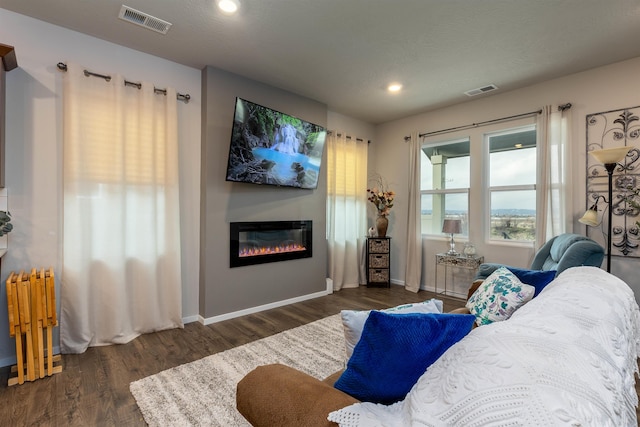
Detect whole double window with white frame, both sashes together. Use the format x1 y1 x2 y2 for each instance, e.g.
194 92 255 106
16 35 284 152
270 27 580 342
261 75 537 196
420 123 537 244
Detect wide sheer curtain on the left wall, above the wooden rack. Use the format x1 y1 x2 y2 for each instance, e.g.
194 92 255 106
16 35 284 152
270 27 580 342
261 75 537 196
60 64 182 353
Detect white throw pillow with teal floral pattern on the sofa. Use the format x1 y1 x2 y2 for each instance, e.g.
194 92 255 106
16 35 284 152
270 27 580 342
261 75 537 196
466 267 536 326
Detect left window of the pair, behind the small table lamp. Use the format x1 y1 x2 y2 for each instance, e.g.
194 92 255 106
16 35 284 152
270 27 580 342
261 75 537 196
420 138 471 236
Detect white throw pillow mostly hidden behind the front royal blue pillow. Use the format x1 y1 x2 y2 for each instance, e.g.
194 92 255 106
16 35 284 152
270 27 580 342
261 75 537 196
340 299 443 359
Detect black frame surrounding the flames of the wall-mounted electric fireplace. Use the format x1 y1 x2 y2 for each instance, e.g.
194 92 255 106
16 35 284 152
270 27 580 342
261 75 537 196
229 220 313 268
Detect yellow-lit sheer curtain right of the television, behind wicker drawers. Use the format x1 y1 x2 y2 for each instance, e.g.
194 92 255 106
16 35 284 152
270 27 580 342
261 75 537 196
327 132 367 291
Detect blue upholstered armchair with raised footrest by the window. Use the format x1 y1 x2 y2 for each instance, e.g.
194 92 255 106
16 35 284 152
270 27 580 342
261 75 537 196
474 233 604 281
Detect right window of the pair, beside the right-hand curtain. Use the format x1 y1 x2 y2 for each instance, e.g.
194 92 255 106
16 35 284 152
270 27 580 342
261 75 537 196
485 126 536 242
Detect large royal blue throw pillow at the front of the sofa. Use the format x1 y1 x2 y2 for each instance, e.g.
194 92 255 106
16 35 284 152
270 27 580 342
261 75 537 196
334 311 475 405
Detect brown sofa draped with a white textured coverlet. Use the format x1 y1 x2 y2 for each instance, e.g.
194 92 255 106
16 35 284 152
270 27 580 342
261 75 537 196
236 267 640 427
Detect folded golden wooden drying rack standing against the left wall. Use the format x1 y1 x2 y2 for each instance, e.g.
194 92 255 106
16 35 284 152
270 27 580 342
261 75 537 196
6 267 62 386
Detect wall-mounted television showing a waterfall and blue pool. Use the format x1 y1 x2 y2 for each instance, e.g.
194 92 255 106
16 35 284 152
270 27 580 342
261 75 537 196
226 98 327 189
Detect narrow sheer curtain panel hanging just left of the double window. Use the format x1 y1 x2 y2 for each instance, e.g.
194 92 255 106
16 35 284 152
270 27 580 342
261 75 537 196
404 132 422 292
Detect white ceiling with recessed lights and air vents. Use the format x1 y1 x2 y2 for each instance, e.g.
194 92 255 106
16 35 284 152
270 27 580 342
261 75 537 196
0 0 640 124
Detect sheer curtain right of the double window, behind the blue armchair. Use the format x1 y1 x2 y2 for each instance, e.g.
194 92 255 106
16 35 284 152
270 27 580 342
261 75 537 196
536 105 573 250
